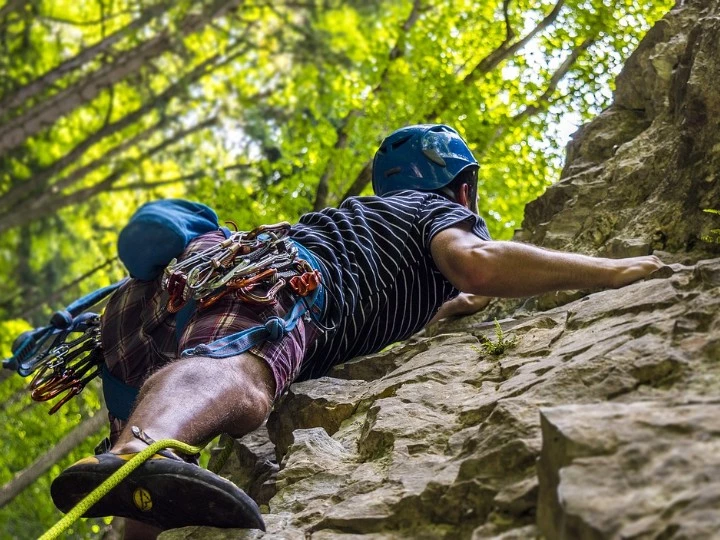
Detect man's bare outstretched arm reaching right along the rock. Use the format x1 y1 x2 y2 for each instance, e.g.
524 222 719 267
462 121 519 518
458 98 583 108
430 225 663 297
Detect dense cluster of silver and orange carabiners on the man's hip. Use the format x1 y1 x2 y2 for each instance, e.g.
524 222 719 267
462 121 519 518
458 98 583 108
162 222 320 313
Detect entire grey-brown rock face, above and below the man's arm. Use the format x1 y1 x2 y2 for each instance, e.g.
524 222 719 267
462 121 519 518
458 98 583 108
161 0 720 540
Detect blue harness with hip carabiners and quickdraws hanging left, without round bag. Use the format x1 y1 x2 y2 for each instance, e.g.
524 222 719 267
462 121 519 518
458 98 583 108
3 215 325 419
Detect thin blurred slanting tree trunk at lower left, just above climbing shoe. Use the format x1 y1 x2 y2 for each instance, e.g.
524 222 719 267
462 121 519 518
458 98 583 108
0 408 107 508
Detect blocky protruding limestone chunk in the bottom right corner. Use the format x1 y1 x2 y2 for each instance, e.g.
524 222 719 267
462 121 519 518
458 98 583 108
538 401 720 538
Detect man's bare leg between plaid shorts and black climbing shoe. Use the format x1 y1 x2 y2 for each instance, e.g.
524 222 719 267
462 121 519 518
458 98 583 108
110 353 275 454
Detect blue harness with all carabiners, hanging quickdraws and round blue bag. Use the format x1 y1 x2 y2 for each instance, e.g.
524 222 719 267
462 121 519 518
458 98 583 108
3 199 325 420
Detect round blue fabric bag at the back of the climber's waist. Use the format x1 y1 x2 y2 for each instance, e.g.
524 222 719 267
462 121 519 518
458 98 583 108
118 199 222 281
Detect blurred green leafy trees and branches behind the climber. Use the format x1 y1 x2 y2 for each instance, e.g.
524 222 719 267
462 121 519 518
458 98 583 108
0 0 672 538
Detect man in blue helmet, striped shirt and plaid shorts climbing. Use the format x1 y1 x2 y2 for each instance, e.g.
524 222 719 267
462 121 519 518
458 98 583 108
52 124 662 534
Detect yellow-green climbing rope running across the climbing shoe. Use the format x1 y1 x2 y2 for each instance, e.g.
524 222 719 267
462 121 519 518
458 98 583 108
39 439 202 540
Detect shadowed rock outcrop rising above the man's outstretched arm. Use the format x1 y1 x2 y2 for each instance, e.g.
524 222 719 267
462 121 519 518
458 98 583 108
516 0 720 260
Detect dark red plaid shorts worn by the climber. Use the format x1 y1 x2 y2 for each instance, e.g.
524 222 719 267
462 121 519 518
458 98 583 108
102 231 317 443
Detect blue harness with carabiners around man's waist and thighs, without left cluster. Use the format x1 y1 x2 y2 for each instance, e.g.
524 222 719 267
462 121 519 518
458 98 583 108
101 228 327 420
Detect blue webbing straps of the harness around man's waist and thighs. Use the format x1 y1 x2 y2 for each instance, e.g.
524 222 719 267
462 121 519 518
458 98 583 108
100 239 325 420
